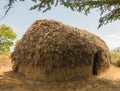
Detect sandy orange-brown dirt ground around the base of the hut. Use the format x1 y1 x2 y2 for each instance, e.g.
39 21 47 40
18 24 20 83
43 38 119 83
0 57 120 91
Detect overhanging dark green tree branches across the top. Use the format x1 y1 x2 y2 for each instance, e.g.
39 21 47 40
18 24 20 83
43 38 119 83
1 0 120 28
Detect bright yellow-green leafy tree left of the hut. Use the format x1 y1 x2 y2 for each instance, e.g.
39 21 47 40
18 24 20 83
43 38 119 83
0 24 16 53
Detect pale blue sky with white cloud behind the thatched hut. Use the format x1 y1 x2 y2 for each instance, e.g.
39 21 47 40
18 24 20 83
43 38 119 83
0 0 120 49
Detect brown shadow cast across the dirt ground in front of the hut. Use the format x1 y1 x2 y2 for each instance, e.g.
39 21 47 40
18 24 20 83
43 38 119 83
0 71 120 91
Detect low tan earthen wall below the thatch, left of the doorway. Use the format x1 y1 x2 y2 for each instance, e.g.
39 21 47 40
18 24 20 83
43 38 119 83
18 64 93 81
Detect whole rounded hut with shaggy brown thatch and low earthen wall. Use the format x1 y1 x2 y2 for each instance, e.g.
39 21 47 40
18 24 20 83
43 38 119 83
11 20 111 81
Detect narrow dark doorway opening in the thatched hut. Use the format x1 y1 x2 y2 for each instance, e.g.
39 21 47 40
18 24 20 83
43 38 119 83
92 52 99 75
